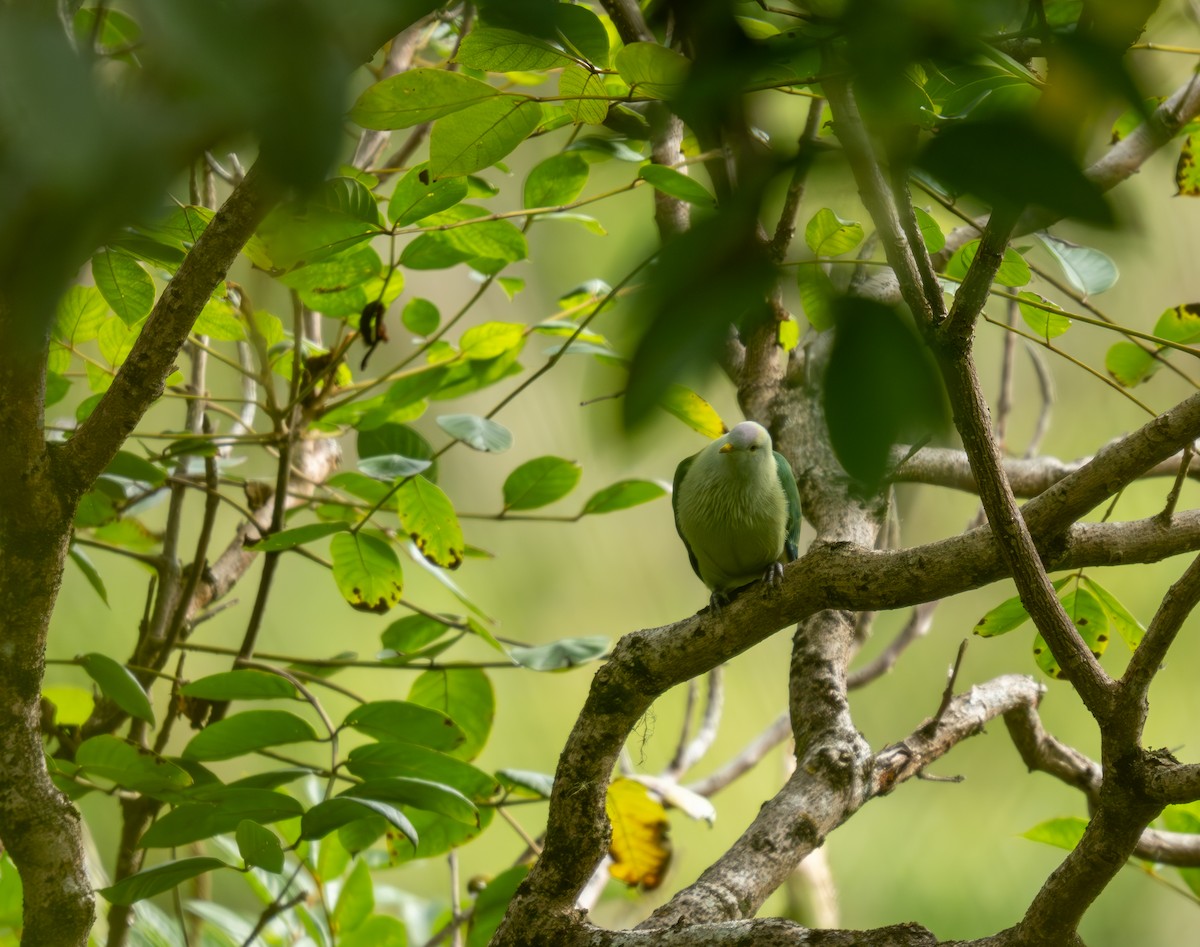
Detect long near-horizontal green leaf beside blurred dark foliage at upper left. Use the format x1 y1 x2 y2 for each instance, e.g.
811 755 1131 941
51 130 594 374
350 68 499 131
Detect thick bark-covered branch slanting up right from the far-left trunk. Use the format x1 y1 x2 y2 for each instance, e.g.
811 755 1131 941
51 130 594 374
54 166 280 496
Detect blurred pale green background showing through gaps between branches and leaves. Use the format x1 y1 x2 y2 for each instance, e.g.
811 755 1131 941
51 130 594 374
39 3 1200 947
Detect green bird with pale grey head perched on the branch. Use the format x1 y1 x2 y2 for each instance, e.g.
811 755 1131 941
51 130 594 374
671 421 800 606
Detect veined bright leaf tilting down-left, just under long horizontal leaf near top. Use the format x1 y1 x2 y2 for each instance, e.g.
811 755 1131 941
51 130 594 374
430 95 541 178
